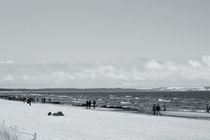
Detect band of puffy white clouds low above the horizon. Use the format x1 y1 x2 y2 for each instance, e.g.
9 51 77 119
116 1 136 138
0 55 210 88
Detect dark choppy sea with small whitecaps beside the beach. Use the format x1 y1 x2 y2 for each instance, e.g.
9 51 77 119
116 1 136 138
0 90 210 113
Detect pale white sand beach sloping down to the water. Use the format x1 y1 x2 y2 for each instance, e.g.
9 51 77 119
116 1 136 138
0 100 210 140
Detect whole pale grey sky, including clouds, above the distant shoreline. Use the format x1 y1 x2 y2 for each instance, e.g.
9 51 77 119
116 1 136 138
0 0 210 88
